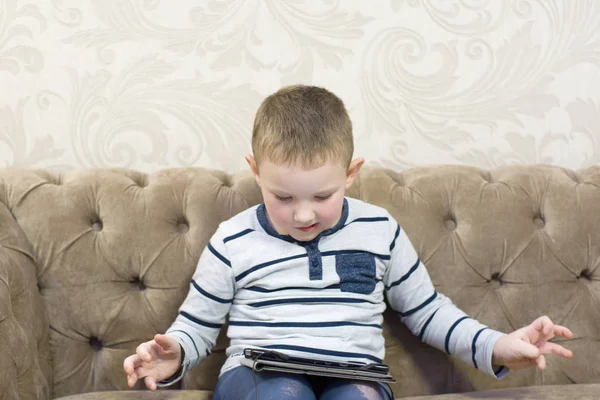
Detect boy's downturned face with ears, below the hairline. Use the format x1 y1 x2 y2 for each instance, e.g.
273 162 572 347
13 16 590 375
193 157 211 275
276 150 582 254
246 155 364 241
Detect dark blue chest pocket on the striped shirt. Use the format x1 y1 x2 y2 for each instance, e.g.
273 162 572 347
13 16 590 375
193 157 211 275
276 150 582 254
335 253 377 294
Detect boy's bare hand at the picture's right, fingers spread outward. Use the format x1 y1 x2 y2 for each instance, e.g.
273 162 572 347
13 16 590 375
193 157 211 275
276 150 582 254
492 316 573 370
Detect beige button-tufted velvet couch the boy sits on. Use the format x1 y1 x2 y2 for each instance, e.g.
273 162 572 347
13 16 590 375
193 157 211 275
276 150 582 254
0 166 600 400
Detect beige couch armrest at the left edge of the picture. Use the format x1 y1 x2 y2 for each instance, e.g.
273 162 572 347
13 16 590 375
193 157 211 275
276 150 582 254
0 203 51 400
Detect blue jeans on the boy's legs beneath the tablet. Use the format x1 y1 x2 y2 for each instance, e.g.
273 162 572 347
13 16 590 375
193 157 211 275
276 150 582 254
213 366 393 400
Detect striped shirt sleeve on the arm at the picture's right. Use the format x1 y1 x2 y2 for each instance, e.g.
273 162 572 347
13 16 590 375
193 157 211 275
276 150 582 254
384 219 508 378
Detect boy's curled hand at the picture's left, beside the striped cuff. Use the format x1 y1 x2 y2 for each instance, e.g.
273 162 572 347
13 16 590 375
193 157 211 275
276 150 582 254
123 334 181 391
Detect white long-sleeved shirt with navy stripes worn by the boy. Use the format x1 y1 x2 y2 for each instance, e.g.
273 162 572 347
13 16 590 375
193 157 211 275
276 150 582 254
161 198 507 384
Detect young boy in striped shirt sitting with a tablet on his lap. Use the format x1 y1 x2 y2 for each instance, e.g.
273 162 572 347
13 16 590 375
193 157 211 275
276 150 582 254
124 86 572 400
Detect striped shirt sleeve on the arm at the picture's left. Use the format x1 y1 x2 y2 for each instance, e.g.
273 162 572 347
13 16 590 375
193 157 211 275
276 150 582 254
157 225 235 386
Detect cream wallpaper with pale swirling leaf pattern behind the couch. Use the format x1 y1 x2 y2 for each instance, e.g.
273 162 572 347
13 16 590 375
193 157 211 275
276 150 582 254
0 0 600 171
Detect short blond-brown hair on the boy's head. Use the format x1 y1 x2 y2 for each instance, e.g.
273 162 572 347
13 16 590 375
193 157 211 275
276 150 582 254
252 85 354 168
